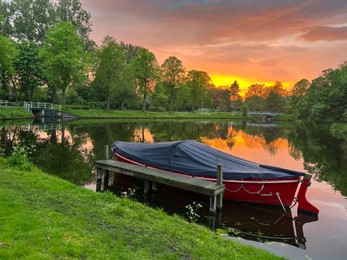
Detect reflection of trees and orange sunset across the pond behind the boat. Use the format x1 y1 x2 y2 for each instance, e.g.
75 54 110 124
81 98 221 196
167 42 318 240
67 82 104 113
0 120 347 196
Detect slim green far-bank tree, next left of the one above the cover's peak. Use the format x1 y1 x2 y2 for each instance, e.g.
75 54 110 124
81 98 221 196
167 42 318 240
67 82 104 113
132 49 159 111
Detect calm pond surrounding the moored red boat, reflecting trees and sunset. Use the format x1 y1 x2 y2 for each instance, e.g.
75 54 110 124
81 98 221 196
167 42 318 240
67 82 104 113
0 120 347 259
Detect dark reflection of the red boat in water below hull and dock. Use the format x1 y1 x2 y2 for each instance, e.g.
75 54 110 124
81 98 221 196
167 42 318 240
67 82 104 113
110 174 318 249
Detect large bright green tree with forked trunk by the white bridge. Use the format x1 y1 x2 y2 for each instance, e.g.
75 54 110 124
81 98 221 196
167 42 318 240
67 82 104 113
39 22 86 106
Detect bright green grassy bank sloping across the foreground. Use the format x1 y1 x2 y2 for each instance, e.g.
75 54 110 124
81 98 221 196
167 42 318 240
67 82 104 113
0 155 280 259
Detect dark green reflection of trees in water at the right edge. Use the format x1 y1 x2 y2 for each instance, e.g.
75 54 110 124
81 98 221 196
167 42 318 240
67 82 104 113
288 125 347 196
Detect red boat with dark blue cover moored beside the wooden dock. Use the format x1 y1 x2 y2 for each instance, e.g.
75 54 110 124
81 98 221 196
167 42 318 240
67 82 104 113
112 140 319 215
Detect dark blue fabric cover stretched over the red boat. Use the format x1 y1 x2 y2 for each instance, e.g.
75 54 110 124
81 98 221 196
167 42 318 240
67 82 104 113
112 140 304 180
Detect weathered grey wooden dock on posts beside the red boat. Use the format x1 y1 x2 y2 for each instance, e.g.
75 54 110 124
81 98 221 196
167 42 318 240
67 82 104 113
95 159 224 213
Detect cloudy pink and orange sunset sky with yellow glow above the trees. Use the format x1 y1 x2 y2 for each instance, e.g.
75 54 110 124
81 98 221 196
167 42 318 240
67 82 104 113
81 0 347 89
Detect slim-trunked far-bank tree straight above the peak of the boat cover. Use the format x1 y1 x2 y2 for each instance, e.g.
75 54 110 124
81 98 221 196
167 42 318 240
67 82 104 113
161 56 185 112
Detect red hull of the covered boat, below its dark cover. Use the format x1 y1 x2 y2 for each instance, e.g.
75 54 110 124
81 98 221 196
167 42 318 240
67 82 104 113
114 152 319 215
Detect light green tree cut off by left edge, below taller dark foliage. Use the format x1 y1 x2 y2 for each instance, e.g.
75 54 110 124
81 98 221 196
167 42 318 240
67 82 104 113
0 35 18 98
